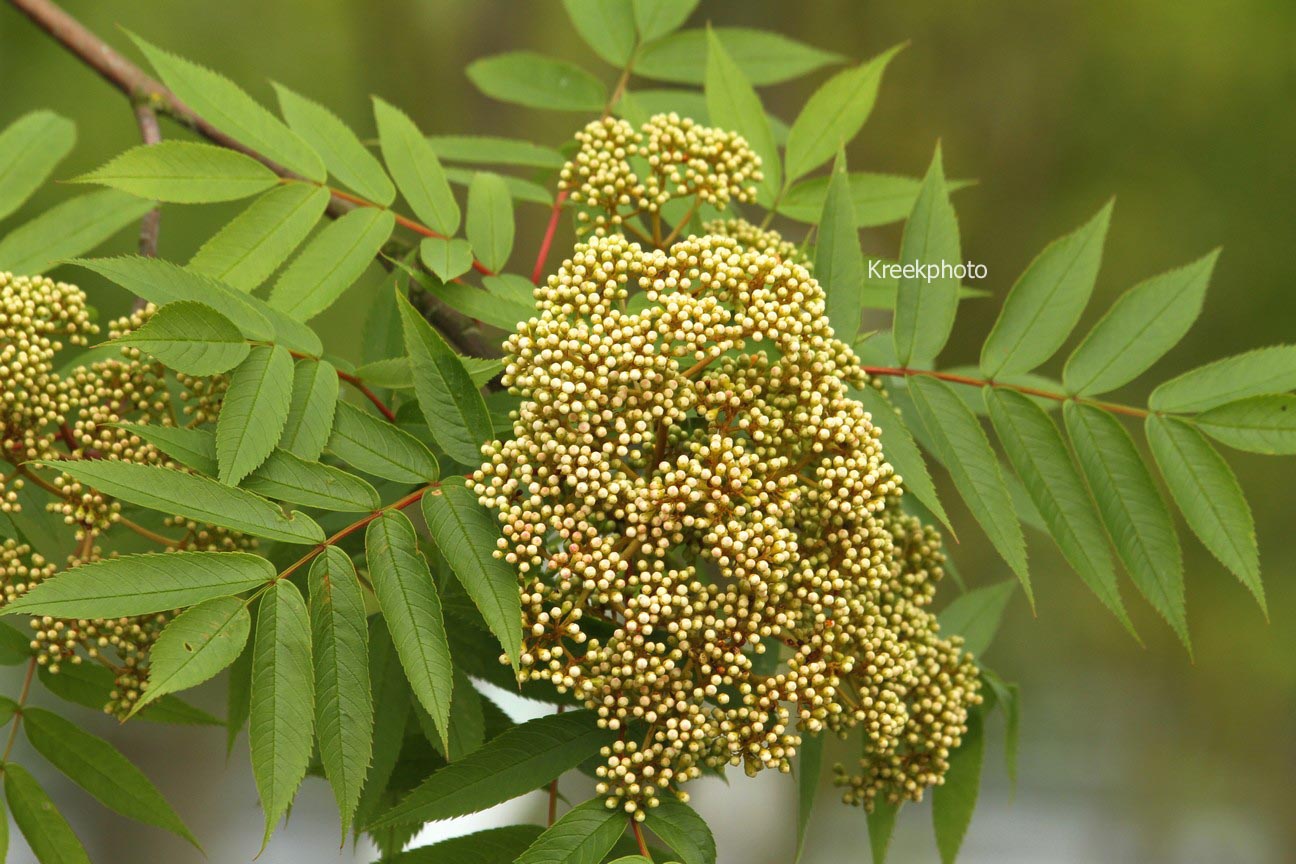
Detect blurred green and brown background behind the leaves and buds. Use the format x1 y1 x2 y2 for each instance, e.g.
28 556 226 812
0 0 1296 864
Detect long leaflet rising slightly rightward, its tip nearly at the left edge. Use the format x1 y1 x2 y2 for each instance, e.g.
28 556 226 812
4 552 275 618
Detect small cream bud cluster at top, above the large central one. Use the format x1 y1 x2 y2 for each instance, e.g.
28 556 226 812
559 114 762 234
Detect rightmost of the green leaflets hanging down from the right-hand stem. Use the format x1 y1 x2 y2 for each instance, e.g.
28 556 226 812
1146 415 1269 615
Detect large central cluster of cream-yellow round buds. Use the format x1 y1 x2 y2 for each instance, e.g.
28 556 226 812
472 227 980 817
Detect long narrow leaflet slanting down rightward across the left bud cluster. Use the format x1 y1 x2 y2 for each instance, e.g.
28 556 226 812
38 459 324 545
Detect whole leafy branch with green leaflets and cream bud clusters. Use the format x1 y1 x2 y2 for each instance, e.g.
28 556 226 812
0 0 1296 864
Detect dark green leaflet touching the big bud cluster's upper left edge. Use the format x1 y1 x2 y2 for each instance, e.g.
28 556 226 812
399 288 495 465
